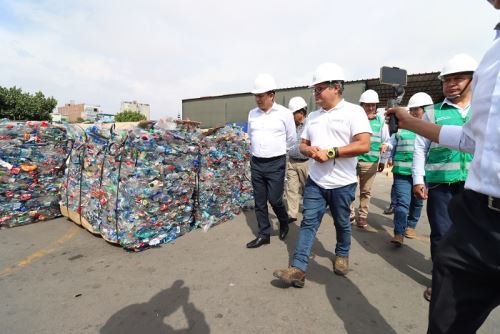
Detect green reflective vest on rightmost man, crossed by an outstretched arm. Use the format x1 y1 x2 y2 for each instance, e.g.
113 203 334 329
425 103 473 183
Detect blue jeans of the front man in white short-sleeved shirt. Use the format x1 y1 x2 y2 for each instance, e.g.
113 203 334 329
292 178 356 271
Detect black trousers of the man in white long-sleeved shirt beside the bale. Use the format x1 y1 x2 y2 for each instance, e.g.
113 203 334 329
250 155 288 236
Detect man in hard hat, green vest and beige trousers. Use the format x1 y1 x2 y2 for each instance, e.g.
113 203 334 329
350 89 390 228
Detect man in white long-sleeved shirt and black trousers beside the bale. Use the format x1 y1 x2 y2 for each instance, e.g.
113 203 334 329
247 73 296 248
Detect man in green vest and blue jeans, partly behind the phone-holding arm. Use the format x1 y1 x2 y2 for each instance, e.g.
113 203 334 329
384 92 434 247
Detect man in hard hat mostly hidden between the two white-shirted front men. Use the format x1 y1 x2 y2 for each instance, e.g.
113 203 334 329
286 96 309 222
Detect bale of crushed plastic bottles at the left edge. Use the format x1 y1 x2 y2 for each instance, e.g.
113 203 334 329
0 119 68 228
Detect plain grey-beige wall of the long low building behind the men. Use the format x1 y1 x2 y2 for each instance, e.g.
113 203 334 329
182 81 365 128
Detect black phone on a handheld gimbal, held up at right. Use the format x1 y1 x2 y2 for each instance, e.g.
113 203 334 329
380 66 407 135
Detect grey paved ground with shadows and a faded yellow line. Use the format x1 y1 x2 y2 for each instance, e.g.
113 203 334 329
0 175 500 334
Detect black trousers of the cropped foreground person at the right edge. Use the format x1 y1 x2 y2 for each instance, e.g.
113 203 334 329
428 190 500 334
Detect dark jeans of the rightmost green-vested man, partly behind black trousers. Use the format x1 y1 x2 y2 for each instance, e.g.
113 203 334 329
427 182 464 259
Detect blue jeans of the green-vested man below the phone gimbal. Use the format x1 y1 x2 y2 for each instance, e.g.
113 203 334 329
394 174 424 235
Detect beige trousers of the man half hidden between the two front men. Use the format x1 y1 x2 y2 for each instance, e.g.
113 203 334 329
285 159 309 219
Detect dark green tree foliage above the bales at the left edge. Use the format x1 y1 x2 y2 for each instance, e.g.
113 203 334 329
0 86 57 121
